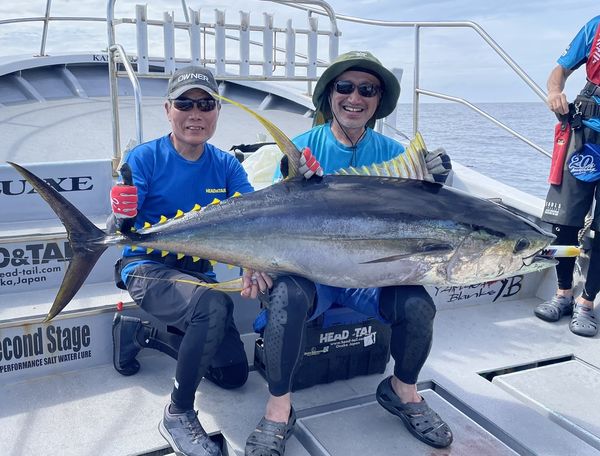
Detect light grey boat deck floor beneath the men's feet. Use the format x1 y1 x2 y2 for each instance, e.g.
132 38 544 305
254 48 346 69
0 299 600 456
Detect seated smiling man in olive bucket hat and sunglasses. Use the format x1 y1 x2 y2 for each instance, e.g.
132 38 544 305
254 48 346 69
246 51 453 456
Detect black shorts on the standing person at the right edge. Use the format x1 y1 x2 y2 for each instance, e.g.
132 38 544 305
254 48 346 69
542 127 600 231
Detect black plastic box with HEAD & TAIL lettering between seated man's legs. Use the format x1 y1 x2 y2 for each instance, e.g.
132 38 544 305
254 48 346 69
254 307 391 391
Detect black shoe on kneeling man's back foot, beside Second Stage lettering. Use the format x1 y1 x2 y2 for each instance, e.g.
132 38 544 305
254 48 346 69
112 312 143 375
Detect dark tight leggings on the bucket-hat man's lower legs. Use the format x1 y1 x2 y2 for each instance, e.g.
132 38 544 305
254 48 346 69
264 276 436 396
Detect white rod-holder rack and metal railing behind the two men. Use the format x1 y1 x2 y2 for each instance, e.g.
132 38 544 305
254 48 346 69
106 0 340 167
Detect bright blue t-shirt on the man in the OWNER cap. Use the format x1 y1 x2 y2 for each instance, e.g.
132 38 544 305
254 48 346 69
121 135 254 282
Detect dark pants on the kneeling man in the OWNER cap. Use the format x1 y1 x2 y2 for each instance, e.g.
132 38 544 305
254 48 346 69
127 263 248 410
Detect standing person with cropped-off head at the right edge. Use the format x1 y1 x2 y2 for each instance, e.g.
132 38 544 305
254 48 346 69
535 16 600 337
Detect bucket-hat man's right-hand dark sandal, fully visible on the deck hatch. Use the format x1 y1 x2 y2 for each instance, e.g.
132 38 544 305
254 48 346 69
376 377 454 448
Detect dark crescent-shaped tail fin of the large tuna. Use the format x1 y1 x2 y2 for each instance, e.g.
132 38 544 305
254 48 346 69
7 162 108 322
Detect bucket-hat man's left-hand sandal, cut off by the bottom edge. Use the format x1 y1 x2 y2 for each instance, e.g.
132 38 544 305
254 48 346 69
244 407 296 456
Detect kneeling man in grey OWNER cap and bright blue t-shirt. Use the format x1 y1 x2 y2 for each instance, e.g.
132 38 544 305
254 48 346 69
111 66 272 456
